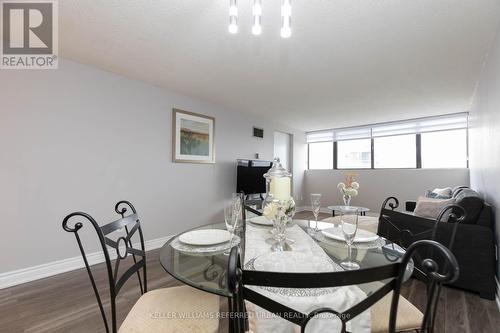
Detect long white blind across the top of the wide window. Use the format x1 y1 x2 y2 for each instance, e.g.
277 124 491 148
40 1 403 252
306 112 469 143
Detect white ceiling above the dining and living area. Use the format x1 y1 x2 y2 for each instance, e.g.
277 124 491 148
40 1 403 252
59 0 500 130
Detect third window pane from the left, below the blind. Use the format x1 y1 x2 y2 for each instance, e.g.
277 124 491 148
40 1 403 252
373 134 417 169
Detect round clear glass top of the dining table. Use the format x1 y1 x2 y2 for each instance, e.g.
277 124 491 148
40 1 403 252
160 220 411 297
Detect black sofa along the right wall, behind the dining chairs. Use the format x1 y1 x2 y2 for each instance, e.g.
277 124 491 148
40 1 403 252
378 187 496 300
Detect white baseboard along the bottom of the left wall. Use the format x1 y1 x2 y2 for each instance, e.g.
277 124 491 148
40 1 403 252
0 236 172 289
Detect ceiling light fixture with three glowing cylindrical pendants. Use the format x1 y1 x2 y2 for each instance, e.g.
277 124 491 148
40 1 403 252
228 0 292 38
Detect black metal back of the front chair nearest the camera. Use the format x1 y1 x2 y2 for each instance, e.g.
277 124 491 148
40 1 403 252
228 240 459 333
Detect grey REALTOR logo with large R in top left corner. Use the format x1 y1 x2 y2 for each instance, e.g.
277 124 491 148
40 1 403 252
0 0 58 69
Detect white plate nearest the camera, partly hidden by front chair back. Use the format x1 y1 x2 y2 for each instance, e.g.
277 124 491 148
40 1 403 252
253 251 335 273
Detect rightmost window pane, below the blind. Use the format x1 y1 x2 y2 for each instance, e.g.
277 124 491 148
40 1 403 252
422 129 467 168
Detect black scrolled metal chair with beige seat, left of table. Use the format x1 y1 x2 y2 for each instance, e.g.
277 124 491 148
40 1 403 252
62 201 219 333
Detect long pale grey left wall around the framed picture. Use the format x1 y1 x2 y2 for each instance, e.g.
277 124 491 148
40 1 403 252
0 61 306 272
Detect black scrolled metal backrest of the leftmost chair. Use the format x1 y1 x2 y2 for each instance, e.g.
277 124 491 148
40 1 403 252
62 201 147 333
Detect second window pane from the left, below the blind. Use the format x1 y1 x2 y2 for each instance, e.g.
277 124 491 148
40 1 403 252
337 139 372 169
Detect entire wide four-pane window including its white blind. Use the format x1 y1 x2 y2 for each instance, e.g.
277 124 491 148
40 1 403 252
306 113 469 169
